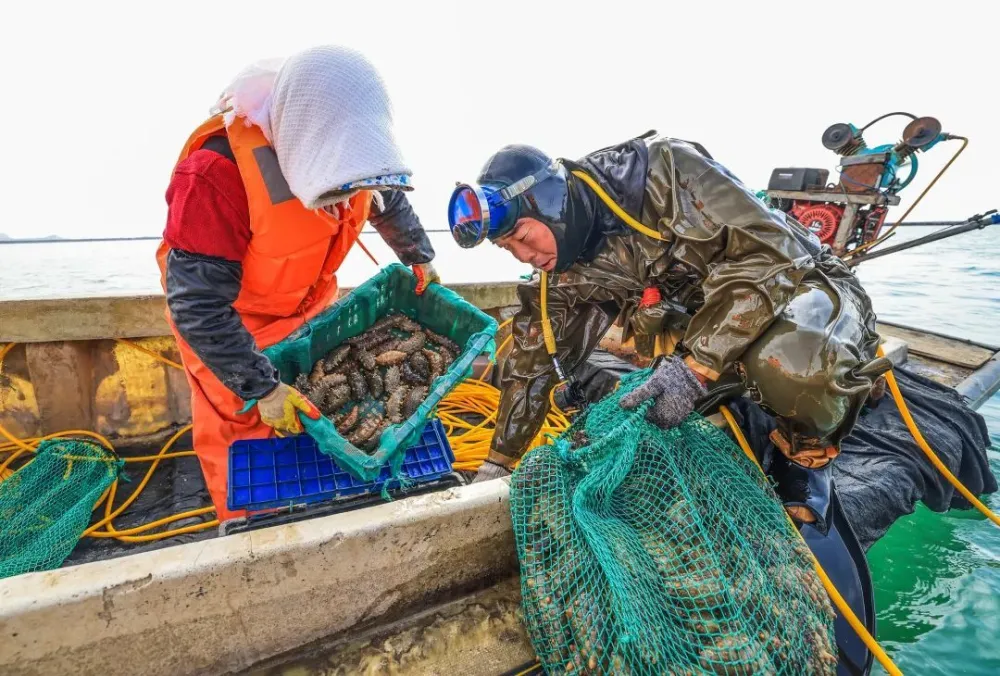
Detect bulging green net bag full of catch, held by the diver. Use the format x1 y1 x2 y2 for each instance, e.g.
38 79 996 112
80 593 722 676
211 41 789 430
511 370 837 676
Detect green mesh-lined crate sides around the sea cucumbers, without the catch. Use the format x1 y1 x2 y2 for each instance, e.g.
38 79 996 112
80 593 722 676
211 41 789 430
264 263 497 481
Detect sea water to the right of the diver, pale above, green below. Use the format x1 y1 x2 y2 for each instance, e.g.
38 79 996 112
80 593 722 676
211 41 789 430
860 226 1000 676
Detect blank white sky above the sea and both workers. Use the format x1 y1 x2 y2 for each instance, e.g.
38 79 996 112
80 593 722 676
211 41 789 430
0 0 1000 237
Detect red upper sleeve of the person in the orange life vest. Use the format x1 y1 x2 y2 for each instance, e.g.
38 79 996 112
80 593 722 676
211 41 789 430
163 150 250 263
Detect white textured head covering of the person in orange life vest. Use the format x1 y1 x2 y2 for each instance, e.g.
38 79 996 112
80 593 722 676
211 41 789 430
216 46 412 209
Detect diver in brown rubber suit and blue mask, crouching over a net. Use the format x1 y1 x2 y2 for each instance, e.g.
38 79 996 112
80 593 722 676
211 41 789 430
449 133 889 529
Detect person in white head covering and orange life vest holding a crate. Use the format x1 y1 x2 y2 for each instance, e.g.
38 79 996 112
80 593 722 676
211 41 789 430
157 47 438 520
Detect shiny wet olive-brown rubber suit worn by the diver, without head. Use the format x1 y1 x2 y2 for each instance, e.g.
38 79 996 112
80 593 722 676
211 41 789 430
488 134 884 476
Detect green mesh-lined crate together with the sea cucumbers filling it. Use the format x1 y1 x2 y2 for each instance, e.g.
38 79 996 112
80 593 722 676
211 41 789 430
264 263 497 486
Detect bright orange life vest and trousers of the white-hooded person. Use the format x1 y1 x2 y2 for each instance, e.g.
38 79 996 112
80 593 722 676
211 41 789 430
156 116 372 520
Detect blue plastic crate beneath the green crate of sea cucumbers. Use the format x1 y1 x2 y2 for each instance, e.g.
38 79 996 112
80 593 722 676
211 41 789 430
226 418 455 511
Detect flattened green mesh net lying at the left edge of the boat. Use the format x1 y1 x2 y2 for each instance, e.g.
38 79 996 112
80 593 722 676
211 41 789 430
0 439 123 578
